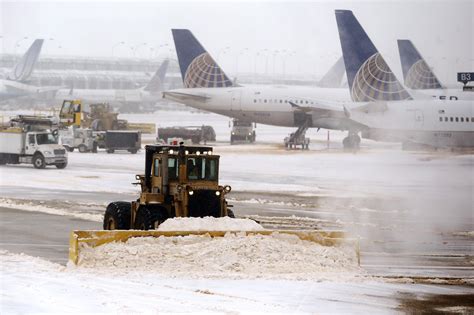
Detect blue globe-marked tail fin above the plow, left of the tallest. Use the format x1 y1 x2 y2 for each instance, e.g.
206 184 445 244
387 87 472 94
172 29 233 88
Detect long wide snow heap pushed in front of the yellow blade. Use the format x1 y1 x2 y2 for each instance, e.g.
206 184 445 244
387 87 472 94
78 233 360 280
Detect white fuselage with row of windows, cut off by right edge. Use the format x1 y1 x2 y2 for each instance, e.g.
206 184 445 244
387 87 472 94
350 100 474 147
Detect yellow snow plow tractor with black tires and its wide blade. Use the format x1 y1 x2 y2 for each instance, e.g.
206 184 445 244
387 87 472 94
69 144 358 265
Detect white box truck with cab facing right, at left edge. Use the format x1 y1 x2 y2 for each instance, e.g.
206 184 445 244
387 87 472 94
0 127 67 169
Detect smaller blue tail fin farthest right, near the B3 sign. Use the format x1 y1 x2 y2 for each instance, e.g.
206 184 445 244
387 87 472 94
397 39 443 90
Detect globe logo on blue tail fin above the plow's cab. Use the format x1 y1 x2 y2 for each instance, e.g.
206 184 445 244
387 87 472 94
184 53 232 88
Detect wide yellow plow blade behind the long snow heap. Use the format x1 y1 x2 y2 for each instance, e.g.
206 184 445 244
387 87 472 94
69 230 360 265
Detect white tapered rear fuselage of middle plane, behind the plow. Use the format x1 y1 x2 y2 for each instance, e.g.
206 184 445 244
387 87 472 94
164 86 350 129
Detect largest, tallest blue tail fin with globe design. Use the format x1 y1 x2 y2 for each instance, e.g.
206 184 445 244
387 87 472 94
336 10 411 102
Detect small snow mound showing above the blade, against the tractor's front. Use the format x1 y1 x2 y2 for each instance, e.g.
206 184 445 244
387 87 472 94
158 217 264 231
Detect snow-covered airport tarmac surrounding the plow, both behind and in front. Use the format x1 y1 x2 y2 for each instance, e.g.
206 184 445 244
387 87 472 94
0 112 474 313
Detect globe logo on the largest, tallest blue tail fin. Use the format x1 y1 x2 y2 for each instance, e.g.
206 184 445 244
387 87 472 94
351 53 411 102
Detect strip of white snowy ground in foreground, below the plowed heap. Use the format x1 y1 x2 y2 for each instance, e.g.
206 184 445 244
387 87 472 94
0 252 474 314
